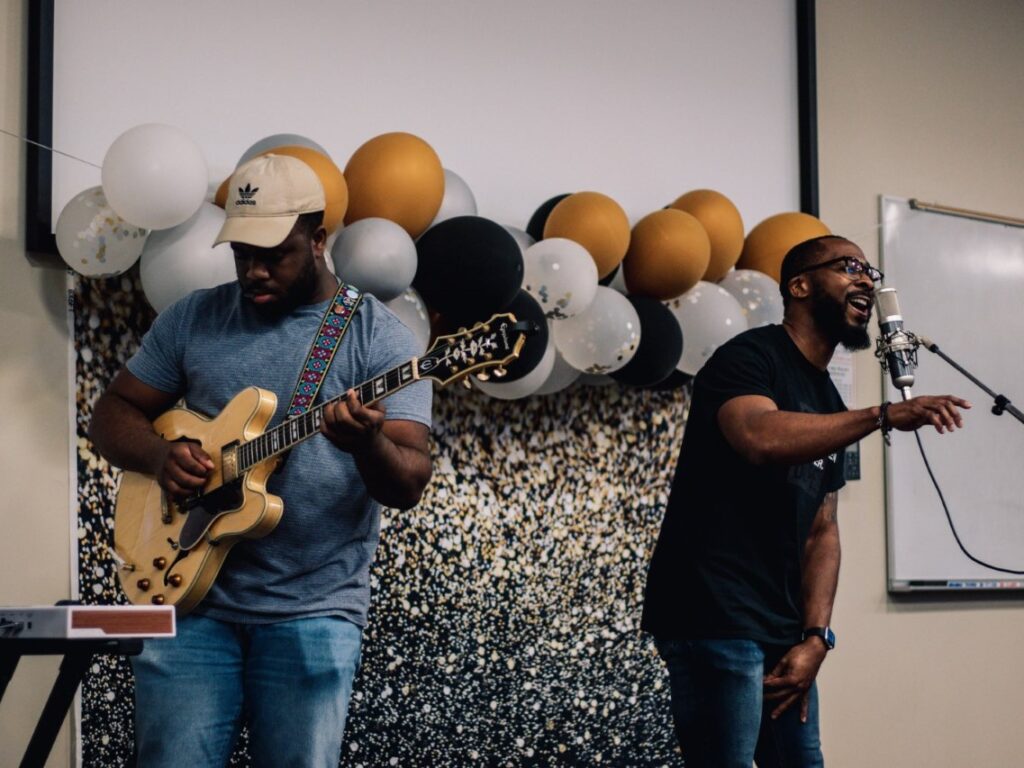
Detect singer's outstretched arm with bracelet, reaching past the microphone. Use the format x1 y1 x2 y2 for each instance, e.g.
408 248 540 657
718 394 971 465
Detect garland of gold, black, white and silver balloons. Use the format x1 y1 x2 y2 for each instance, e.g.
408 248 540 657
56 124 828 399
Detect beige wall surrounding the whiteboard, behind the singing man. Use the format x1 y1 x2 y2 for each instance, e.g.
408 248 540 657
817 0 1024 768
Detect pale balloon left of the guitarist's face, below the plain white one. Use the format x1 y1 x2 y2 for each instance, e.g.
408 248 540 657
139 203 238 312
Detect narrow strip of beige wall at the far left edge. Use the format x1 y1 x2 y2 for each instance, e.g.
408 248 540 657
0 0 73 766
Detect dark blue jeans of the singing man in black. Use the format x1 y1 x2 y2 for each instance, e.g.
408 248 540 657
655 640 824 768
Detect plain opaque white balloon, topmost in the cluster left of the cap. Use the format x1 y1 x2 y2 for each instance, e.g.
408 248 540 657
101 123 209 229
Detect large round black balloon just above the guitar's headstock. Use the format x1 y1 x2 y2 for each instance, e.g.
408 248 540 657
413 216 522 325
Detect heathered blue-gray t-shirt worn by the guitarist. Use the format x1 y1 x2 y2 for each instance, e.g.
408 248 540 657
127 283 432 627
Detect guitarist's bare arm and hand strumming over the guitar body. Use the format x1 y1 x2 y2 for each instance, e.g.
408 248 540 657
89 369 214 496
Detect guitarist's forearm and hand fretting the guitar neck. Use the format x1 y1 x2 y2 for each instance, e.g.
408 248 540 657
321 390 432 509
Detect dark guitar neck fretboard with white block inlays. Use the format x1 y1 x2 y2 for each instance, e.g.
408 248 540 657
238 357 420 473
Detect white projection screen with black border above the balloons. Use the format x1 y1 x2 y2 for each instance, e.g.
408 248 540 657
46 0 800 234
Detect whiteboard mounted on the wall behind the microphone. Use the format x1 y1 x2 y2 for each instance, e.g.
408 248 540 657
881 197 1024 591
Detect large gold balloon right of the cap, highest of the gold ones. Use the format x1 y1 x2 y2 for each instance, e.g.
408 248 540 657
345 133 444 238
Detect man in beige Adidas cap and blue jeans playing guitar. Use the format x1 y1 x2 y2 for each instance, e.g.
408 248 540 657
90 155 431 767
